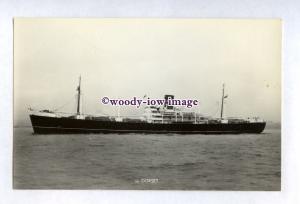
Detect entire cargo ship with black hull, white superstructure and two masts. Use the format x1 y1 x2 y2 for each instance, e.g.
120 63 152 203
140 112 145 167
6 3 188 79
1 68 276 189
29 77 266 134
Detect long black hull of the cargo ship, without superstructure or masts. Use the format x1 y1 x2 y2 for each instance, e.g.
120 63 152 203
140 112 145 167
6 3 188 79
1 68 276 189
30 115 266 134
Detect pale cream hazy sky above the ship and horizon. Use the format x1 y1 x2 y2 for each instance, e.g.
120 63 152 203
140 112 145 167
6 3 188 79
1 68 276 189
14 18 282 125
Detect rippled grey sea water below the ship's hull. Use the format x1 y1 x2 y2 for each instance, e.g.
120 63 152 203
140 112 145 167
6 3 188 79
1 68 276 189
13 128 281 191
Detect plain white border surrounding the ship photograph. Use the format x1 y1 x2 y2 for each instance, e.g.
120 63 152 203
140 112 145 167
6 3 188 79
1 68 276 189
0 0 300 204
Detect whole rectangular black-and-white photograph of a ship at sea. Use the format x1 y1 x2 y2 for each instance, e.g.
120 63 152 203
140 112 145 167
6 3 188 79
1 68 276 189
12 17 282 191
